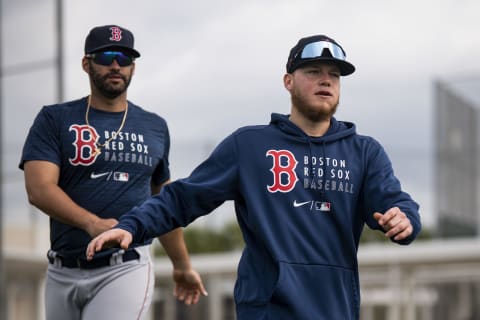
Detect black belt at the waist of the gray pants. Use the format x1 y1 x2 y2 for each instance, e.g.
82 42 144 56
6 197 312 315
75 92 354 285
47 249 140 269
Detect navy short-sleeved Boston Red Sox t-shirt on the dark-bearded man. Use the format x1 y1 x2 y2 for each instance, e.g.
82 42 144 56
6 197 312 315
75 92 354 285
19 98 170 256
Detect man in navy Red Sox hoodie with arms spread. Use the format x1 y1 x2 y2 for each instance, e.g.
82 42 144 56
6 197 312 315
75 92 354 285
87 35 421 320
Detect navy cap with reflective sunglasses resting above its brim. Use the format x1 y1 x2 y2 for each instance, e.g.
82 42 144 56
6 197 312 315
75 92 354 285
287 35 355 76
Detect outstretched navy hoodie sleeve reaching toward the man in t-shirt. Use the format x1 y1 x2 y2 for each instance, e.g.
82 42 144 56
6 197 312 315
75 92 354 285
117 132 242 242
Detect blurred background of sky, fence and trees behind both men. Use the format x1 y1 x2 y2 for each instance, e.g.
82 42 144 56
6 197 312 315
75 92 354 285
0 0 480 320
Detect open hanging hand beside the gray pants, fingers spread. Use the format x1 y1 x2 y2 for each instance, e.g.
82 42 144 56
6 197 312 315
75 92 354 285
173 269 208 305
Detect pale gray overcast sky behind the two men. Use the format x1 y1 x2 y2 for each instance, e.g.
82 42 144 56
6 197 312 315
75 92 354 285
1 0 480 230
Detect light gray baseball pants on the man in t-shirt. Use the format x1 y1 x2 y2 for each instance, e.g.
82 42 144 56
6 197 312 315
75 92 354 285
45 246 154 320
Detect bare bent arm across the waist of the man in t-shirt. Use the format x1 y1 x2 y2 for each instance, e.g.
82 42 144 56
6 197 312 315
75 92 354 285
24 160 117 237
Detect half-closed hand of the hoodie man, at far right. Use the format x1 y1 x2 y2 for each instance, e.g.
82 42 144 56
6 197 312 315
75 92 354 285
373 207 413 241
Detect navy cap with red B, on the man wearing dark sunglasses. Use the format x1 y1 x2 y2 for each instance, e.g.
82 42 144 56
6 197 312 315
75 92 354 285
85 25 140 58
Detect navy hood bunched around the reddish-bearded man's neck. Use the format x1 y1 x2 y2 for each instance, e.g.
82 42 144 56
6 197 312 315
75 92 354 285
270 113 356 143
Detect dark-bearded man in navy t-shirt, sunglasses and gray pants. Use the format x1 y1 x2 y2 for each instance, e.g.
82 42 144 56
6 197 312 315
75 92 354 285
19 25 206 320
